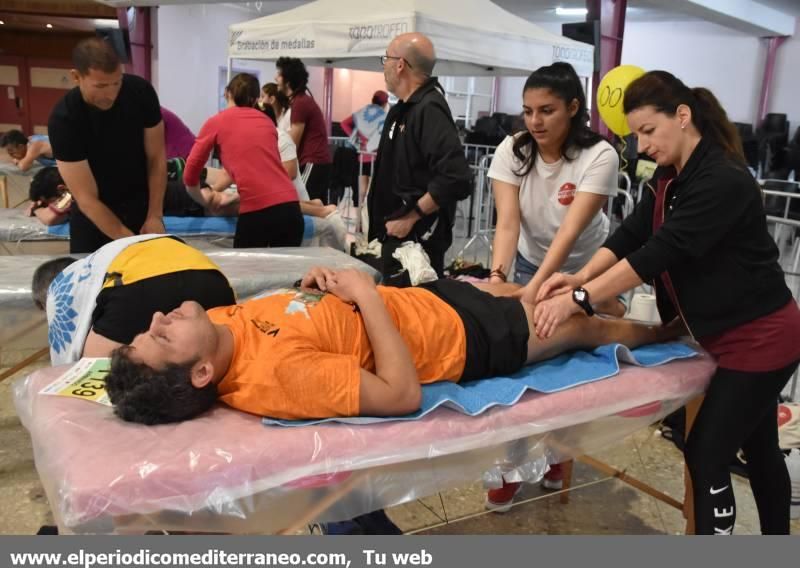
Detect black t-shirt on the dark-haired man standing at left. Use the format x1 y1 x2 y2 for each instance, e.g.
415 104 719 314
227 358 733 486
48 75 161 209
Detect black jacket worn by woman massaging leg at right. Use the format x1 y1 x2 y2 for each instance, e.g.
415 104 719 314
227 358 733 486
603 138 792 338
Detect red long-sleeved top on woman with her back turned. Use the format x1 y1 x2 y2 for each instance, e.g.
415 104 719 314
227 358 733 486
183 107 297 214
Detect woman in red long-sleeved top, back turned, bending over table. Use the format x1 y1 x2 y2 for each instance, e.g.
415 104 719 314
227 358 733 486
183 73 304 248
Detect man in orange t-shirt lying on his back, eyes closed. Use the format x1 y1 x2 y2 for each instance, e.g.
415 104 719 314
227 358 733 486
106 268 680 424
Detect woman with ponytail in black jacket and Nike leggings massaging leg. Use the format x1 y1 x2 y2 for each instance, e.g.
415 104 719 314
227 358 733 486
534 71 800 534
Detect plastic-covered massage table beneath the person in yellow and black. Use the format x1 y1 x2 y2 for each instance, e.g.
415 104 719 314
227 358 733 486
0 246 379 370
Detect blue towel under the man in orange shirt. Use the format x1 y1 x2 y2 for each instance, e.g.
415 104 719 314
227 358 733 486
263 342 697 426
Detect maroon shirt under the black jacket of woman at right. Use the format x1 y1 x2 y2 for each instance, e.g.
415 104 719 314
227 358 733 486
653 179 800 373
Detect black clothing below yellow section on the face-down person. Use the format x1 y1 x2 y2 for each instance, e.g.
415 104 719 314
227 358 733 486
92 270 236 345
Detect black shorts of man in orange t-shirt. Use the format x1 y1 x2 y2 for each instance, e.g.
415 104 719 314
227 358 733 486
418 279 530 381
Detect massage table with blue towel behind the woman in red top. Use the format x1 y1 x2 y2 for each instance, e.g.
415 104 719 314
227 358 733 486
0 207 345 256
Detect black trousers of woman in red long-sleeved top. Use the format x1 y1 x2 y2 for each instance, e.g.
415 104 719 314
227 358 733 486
233 201 305 248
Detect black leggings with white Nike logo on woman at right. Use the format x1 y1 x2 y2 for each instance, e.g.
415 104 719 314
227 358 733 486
684 362 797 534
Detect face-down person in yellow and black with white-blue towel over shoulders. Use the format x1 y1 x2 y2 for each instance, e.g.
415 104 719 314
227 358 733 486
31 235 236 363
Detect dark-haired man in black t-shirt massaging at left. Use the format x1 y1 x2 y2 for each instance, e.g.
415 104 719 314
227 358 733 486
48 38 167 253
